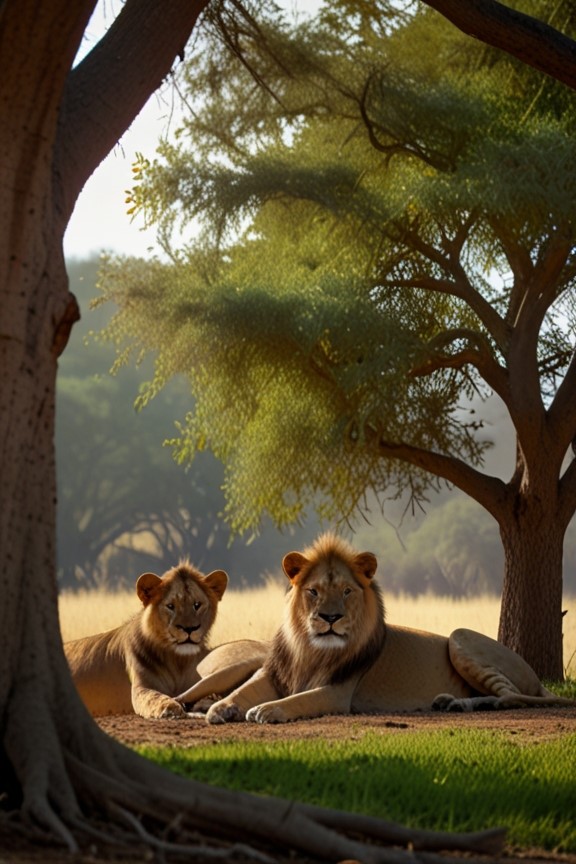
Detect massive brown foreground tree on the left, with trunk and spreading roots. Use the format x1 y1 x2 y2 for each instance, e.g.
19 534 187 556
0 0 434 861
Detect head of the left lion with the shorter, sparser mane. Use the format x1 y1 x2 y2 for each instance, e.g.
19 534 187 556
136 563 228 655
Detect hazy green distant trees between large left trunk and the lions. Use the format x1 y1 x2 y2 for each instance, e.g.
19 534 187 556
56 260 324 588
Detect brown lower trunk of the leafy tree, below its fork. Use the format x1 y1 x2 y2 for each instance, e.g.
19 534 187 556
498 498 565 681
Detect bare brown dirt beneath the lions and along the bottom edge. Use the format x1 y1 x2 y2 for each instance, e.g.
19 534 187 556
0 708 576 864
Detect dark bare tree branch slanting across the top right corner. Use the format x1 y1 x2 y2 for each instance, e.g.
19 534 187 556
423 0 576 90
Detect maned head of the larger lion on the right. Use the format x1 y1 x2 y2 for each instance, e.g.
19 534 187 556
282 535 383 656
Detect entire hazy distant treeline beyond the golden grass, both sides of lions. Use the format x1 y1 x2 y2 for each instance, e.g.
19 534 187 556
56 258 576 596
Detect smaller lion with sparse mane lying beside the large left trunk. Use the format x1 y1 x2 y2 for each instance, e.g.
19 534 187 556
64 561 228 718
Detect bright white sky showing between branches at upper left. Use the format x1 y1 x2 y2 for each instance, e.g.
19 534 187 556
64 0 319 258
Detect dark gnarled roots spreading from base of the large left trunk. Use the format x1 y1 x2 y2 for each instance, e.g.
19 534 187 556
0 713 505 864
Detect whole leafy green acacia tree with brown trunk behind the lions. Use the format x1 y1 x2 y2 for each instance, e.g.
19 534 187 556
97 4 576 679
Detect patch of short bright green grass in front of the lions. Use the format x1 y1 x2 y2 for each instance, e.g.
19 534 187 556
140 723 576 852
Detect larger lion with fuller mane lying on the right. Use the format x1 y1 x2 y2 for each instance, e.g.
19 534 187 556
178 533 576 723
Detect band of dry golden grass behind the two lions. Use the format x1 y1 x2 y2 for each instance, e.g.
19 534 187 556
60 579 576 678
